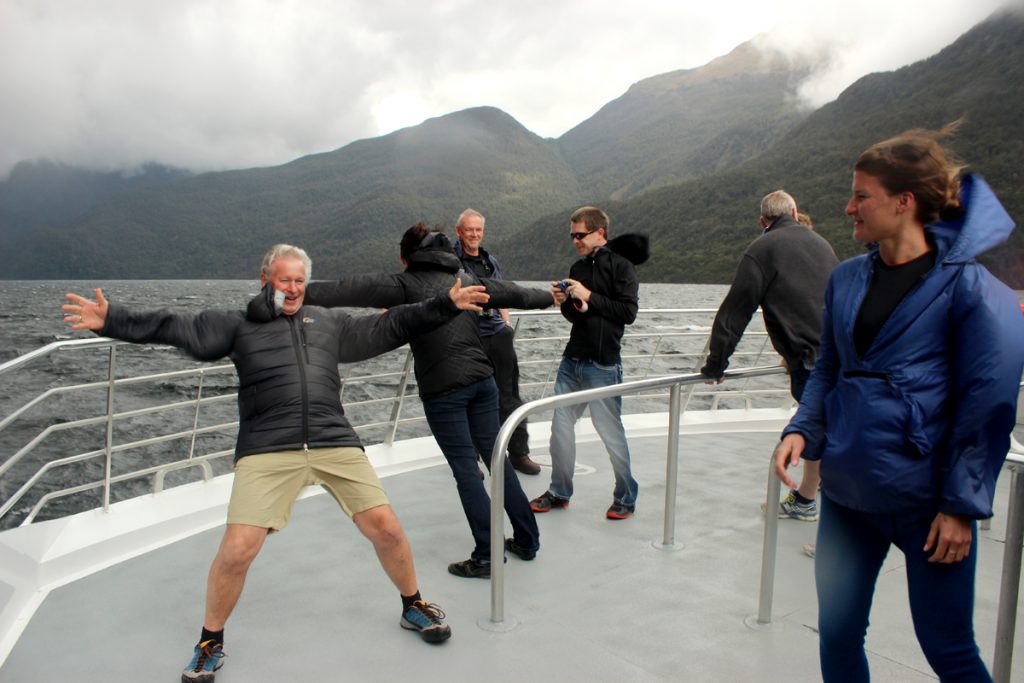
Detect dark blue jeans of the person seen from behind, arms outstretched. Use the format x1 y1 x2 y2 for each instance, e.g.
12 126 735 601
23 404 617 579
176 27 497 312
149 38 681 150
423 377 541 562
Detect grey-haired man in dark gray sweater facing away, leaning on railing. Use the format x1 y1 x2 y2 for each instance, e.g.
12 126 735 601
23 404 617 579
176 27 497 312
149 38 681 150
700 189 839 521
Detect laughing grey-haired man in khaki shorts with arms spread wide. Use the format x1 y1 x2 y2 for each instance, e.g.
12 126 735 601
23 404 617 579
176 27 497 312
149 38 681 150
62 245 487 683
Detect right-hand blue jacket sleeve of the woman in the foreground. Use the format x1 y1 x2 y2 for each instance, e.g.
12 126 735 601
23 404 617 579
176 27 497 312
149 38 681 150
939 267 1024 519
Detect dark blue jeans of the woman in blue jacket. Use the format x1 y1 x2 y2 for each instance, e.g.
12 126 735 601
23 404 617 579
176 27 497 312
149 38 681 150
814 492 992 683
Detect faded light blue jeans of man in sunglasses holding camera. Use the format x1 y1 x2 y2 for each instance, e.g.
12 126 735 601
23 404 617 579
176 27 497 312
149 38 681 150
548 358 640 506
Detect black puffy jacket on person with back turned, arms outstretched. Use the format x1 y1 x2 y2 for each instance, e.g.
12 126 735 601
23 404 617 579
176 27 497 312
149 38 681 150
292 242 554 398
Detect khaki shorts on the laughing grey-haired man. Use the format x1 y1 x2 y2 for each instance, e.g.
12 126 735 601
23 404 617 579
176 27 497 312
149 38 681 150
227 446 387 531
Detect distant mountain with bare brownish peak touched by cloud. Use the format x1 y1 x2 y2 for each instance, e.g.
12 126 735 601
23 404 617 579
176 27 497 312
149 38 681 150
558 39 812 200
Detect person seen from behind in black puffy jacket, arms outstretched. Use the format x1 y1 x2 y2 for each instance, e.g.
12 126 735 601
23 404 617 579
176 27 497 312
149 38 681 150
248 228 554 579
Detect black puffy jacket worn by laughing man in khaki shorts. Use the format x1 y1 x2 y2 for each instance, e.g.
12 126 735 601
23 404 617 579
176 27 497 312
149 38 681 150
99 292 462 460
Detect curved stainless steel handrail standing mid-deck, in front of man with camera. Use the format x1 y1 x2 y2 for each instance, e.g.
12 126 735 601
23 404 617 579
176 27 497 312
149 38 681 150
490 366 785 625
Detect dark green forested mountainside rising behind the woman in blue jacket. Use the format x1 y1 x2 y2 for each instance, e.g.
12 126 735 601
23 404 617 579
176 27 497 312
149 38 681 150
492 11 1024 289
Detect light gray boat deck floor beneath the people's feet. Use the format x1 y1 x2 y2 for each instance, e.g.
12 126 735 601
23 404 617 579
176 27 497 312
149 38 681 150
0 433 1024 683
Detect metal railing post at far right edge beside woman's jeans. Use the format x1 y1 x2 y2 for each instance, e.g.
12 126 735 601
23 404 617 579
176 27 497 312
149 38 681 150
992 465 1024 683
